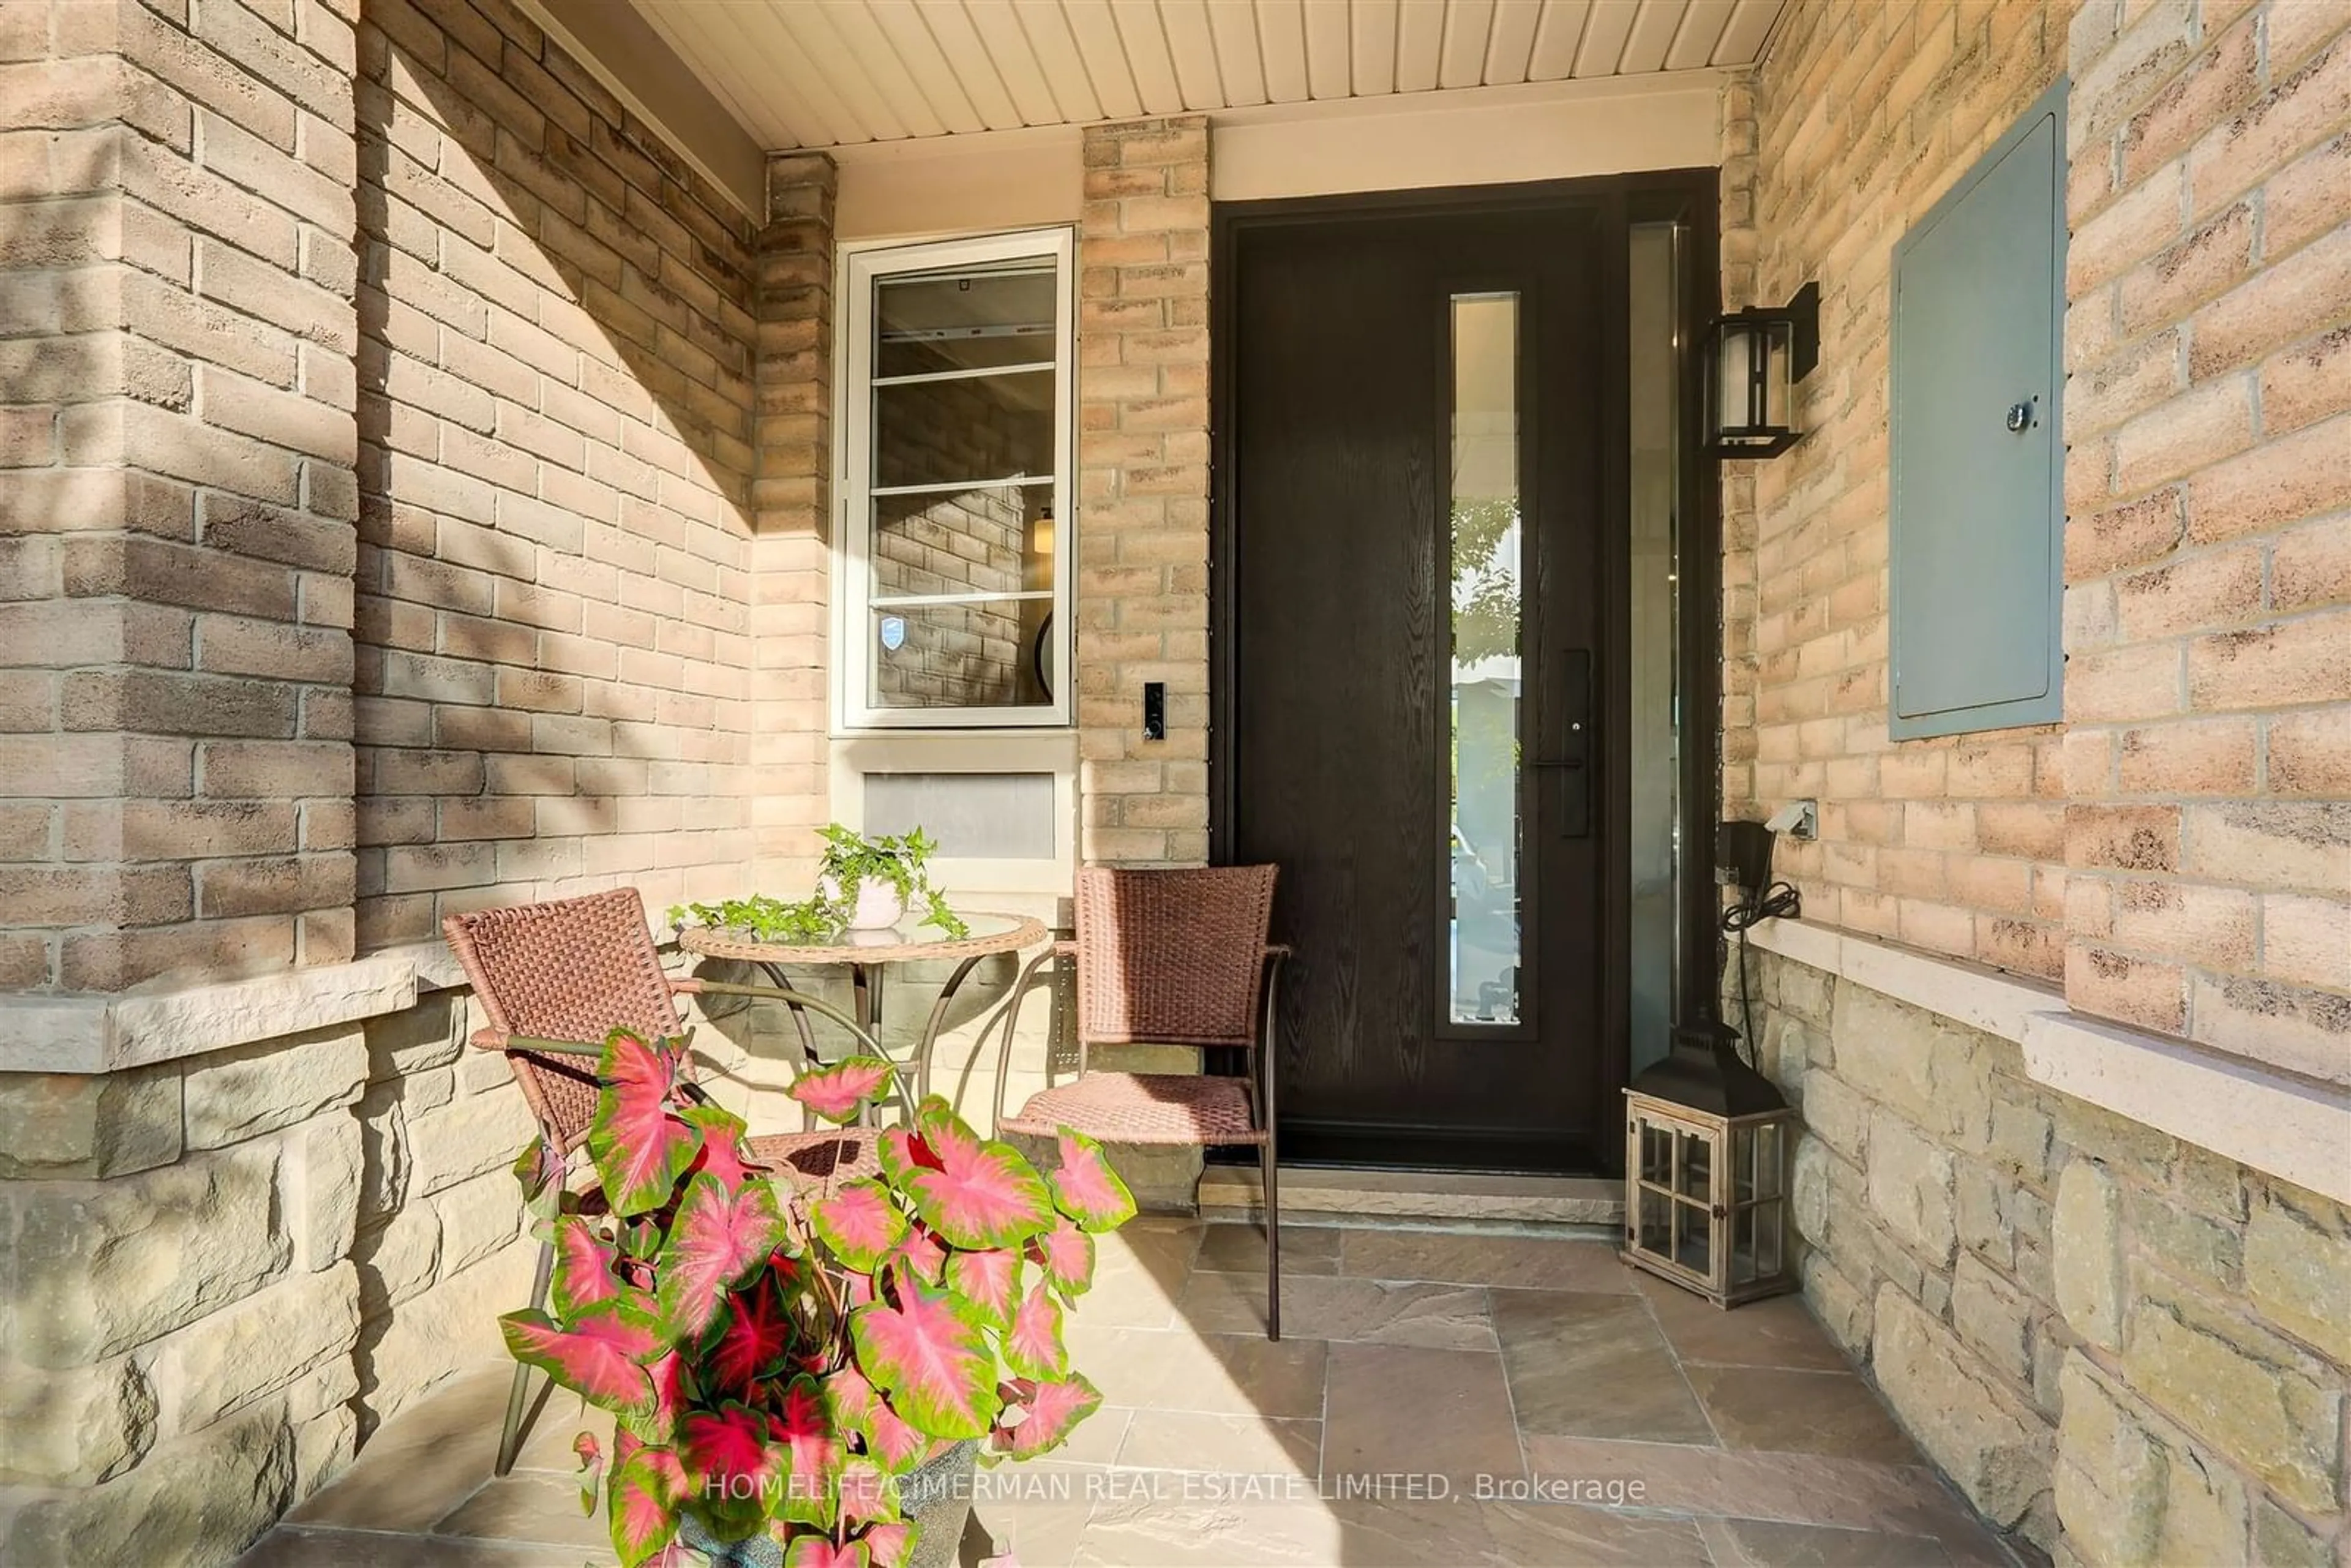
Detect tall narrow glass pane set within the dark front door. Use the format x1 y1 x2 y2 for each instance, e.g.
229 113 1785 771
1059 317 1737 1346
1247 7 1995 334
1446 294 1526 1025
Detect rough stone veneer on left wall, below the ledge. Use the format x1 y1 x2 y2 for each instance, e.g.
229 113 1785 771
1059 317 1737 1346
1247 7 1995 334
0 985 534 1566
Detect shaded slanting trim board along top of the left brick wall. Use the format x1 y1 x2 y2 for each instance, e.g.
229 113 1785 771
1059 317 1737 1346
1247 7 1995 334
515 0 767 223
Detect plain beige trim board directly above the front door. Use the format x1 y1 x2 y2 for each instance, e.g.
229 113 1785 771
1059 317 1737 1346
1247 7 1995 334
1209 70 1733 202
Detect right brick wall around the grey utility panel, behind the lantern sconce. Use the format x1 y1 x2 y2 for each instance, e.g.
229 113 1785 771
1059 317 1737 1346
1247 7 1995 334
1723 0 2069 978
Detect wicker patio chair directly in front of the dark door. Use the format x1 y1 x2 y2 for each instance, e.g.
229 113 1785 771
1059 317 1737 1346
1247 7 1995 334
997 865 1291 1340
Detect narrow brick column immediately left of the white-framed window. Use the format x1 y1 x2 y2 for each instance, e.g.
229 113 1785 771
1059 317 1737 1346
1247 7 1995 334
752 153 839 887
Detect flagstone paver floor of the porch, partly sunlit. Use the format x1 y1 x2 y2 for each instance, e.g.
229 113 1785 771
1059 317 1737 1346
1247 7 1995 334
244 1218 2015 1568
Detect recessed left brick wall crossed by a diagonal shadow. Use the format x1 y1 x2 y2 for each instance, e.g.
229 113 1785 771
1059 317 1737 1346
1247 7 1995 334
358 0 755 945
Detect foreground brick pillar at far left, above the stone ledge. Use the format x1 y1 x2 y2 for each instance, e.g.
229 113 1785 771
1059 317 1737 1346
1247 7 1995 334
0 0 358 992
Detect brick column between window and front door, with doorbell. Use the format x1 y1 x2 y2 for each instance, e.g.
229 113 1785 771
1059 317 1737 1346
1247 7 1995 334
1077 115 1209 865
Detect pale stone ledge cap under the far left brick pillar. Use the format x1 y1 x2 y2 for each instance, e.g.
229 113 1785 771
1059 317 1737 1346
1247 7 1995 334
0 955 419 1072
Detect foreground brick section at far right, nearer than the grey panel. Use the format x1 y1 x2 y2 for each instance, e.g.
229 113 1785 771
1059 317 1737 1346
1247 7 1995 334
2064 0 2351 1081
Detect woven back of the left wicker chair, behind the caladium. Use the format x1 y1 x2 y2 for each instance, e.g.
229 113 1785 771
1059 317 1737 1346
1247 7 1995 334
442 888 684 1154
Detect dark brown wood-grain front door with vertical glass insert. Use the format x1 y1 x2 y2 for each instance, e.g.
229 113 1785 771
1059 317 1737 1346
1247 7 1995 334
1218 202 1624 1171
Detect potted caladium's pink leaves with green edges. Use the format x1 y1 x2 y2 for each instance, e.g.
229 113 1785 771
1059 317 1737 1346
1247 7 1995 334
503 1030 1136 1568
